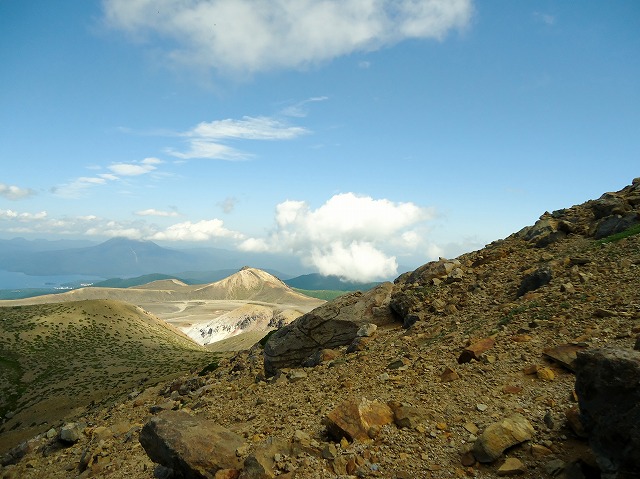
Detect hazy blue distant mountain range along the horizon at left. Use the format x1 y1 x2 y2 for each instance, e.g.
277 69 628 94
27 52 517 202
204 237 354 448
0 238 377 299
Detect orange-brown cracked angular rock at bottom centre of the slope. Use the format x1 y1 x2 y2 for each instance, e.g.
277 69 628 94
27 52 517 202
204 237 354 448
323 397 394 441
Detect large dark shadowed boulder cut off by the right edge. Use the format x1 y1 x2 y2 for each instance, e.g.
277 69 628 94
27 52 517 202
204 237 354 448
574 348 640 479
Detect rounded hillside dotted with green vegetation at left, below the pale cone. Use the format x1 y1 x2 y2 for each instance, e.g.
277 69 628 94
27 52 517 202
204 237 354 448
0 300 215 451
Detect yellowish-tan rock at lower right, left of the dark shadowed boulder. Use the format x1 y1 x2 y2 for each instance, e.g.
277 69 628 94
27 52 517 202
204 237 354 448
472 413 535 462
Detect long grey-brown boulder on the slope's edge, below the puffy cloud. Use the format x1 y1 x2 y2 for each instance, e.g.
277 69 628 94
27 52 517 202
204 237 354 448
264 282 396 376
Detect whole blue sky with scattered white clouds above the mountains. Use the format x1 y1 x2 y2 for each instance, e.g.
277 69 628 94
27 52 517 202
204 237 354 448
0 0 640 280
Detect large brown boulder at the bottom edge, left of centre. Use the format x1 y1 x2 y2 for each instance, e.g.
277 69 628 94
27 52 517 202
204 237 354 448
140 411 244 479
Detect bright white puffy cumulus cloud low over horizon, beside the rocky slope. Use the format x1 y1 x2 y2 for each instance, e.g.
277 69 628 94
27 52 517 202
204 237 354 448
239 193 434 281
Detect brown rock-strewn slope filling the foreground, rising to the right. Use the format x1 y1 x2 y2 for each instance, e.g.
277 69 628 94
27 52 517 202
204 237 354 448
0 179 640 479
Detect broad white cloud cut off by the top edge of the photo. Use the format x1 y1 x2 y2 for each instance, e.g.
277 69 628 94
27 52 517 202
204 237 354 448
103 0 472 73
